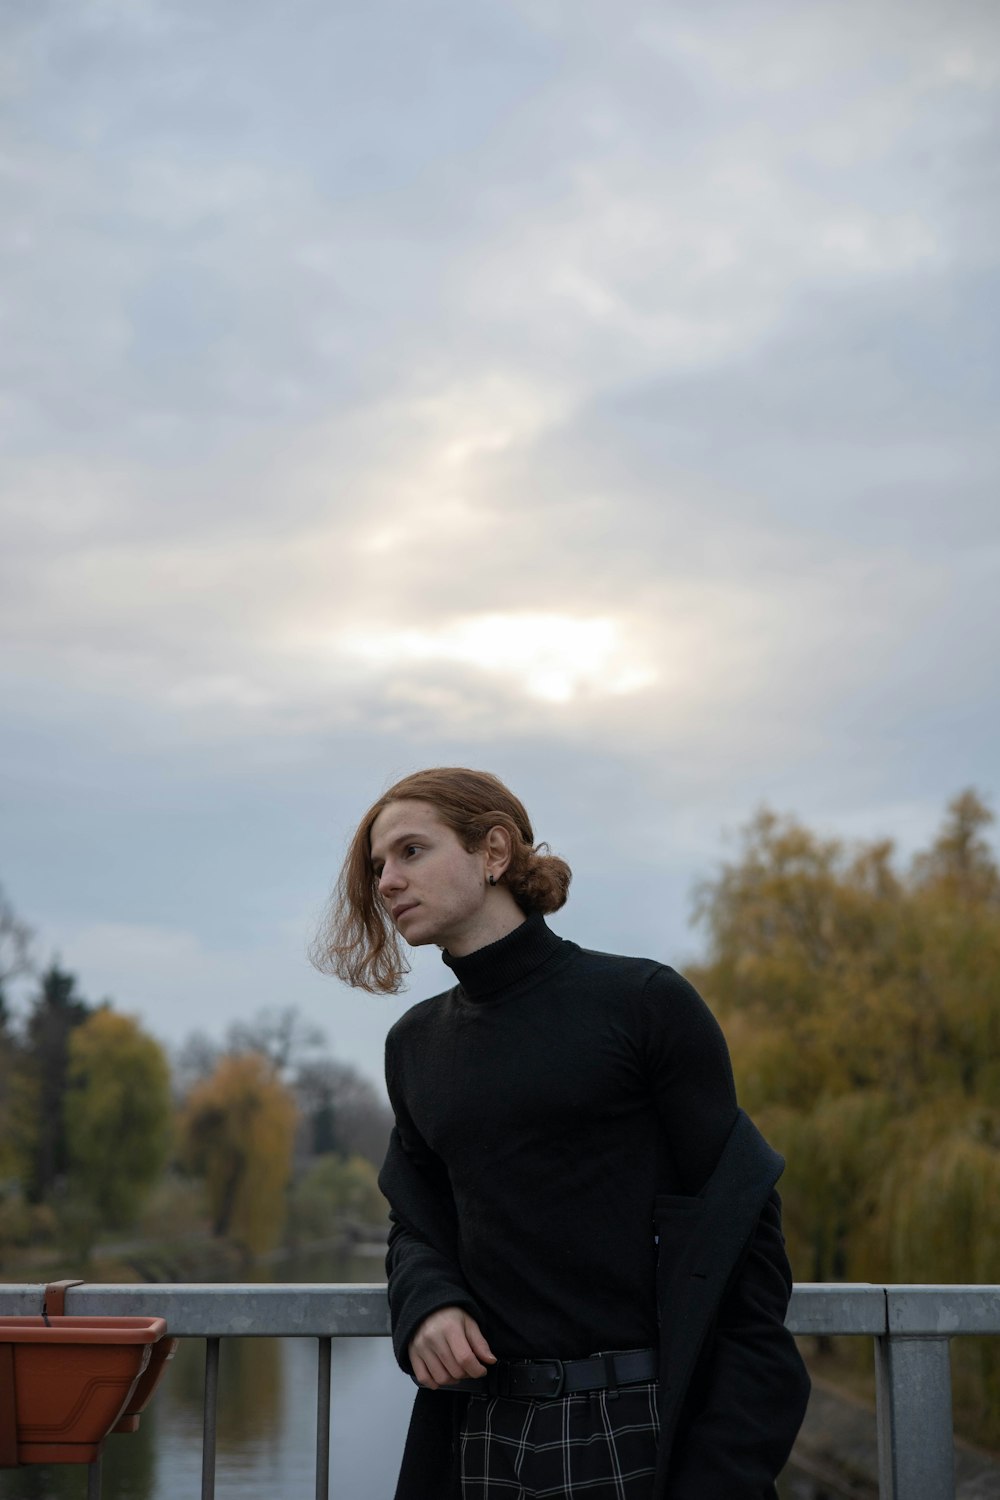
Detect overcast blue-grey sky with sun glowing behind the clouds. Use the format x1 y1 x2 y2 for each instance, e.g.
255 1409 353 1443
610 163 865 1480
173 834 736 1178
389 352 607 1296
0 0 1000 1079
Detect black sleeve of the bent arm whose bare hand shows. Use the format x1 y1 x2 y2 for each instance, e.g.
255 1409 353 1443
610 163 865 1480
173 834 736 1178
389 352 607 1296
379 1047 483 1376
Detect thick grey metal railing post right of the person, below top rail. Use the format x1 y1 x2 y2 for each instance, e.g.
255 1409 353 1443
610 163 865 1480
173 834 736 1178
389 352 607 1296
876 1334 955 1500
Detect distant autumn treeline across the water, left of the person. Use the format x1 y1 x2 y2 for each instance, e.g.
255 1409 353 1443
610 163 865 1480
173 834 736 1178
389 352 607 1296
0 891 391 1277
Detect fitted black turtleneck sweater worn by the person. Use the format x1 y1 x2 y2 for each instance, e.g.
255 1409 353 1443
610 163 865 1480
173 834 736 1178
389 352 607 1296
385 915 736 1365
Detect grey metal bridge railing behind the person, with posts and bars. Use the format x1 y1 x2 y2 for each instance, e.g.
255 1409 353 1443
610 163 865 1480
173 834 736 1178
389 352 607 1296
0 1283 1000 1500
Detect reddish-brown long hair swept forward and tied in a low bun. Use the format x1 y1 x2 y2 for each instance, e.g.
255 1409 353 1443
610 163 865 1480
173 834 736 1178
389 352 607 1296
309 767 571 995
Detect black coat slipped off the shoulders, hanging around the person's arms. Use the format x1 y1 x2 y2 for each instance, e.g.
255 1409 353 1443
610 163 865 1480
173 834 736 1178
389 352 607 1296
381 1110 810 1500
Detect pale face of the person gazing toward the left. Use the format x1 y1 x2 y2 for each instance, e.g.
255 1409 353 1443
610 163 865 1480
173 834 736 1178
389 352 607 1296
370 800 489 954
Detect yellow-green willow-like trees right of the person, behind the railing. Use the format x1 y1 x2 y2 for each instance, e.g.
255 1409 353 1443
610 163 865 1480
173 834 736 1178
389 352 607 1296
690 791 1000 1445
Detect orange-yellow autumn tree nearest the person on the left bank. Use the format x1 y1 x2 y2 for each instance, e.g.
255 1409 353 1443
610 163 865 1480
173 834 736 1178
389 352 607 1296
180 1052 297 1253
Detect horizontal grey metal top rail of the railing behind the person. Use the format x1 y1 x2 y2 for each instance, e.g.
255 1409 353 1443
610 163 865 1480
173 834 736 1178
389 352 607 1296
0 1281 1000 1338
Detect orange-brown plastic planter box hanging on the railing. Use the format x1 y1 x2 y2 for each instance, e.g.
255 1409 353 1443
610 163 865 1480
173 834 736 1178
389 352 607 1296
0 1317 166 1467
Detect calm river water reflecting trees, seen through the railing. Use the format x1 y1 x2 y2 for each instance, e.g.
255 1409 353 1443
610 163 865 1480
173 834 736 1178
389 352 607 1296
0 1257 847 1500
